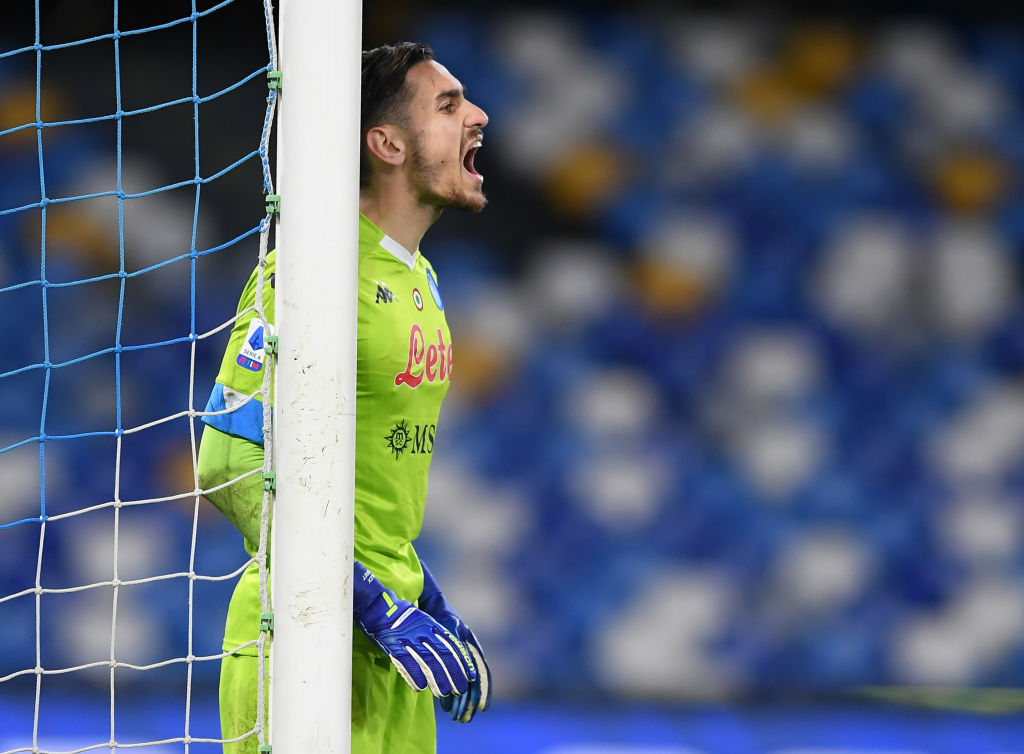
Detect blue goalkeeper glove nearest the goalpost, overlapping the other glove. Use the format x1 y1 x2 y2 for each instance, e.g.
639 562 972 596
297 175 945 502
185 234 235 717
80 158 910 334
352 560 476 698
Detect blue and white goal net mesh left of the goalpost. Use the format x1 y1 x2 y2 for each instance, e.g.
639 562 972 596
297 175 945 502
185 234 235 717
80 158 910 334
0 0 278 754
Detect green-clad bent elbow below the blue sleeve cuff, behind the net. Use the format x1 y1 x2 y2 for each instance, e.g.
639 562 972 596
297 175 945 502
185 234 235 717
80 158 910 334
197 425 263 549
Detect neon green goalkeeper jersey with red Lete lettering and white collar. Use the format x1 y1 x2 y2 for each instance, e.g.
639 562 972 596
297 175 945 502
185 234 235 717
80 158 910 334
204 213 452 651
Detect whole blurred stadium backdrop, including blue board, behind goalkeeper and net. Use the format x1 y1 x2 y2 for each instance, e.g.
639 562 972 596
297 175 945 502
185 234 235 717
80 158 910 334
0 0 1024 754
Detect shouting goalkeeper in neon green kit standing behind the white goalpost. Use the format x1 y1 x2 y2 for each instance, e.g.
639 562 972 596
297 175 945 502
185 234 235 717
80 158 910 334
199 42 490 754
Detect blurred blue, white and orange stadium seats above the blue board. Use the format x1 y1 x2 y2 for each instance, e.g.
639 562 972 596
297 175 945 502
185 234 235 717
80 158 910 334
0 5 1024 700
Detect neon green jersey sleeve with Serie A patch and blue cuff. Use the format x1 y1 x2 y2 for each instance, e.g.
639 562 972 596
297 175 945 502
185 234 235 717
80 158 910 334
203 251 276 445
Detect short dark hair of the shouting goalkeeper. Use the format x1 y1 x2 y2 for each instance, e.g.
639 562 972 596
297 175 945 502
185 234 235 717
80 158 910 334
359 42 434 187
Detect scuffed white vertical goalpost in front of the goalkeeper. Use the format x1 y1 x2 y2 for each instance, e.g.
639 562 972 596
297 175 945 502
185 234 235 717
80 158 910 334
270 0 361 754
